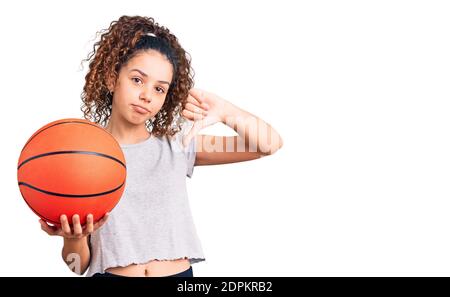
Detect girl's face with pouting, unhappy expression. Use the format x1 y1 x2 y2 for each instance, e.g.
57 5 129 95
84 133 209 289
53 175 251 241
111 50 173 125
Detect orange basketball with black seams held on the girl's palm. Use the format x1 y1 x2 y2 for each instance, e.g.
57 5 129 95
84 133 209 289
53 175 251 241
17 119 127 226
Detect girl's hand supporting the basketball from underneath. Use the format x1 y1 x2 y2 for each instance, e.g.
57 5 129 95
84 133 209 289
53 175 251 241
39 213 109 239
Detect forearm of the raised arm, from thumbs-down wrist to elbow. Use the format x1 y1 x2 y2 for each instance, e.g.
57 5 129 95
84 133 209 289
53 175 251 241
222 101 283 155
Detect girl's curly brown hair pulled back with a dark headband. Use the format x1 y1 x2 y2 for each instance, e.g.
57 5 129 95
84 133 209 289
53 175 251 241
81 16 194 136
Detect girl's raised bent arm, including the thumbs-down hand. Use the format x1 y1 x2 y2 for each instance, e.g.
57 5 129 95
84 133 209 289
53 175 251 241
183 89 283 165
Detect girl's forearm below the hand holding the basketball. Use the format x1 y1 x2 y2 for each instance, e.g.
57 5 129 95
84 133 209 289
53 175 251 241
61 236 91 275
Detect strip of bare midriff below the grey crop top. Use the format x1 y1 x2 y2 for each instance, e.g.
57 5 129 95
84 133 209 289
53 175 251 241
106 258 191 276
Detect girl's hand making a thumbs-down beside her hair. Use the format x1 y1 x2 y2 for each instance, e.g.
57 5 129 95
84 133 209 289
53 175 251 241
182 88 227 146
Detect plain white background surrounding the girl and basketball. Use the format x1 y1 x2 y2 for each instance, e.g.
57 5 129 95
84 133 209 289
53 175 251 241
0 0 450 276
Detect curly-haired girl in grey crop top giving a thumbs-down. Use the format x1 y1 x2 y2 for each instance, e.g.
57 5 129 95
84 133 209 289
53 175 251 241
40 16 282 276
